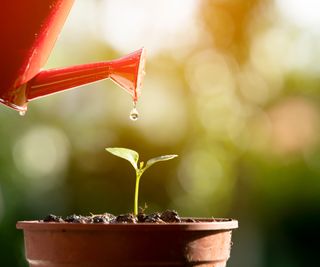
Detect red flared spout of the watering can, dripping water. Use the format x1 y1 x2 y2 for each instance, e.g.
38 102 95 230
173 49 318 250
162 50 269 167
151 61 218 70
25 48 145 107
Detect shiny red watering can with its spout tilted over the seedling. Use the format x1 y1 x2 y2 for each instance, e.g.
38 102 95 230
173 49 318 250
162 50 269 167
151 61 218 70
0 0 145 112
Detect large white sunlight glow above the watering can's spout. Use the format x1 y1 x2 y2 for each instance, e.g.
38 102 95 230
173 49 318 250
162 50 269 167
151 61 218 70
100 0 197 53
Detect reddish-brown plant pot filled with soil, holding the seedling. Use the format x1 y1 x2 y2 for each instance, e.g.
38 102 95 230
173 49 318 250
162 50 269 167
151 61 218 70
17 219 238 267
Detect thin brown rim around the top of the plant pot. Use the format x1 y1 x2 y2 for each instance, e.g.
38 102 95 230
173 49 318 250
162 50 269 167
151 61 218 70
16 218 238 231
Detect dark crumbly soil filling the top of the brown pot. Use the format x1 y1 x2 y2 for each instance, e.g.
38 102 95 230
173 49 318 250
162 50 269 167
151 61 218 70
42 210 188 223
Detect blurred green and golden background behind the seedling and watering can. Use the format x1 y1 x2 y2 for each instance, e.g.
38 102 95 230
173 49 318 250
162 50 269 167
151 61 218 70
0 0 320 267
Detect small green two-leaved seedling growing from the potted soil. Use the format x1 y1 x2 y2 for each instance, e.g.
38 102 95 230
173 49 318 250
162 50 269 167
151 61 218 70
106 147 178 216
